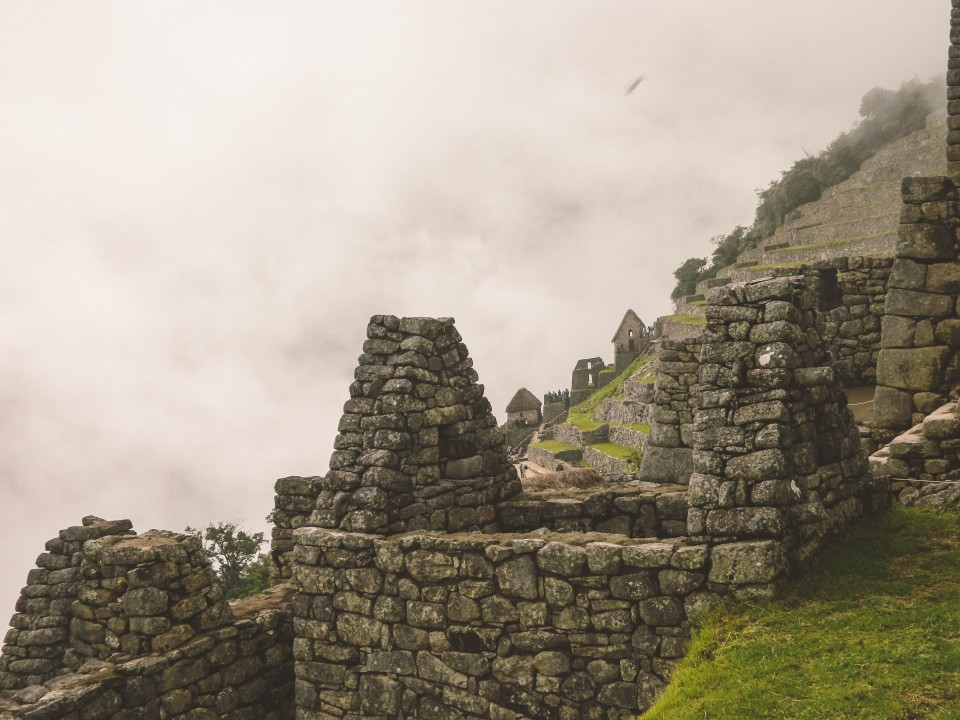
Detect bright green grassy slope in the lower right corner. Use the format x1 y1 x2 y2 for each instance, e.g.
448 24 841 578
642 508 960 720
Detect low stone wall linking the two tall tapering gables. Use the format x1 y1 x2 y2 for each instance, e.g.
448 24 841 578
497 482 688 538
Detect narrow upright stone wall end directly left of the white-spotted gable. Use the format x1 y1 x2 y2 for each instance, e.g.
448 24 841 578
639 334 701 485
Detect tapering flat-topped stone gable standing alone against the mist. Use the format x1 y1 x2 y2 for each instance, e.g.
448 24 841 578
310 315 520 533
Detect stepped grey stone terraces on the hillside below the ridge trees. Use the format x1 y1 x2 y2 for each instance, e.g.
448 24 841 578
677 111 947 315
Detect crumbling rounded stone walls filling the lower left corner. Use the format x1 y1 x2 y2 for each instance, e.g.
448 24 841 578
0 518 294 720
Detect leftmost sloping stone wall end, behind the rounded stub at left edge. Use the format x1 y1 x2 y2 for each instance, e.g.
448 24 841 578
0 515 131 690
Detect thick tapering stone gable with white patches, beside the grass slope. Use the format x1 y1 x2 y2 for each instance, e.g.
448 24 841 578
687 277 877 572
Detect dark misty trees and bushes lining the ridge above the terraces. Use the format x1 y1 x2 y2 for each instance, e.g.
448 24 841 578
670 78 944 300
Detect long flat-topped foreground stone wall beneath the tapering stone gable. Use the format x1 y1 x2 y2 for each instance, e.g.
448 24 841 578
294 528 723 720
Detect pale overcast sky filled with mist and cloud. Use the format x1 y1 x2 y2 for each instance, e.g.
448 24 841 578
0 0 950 622
